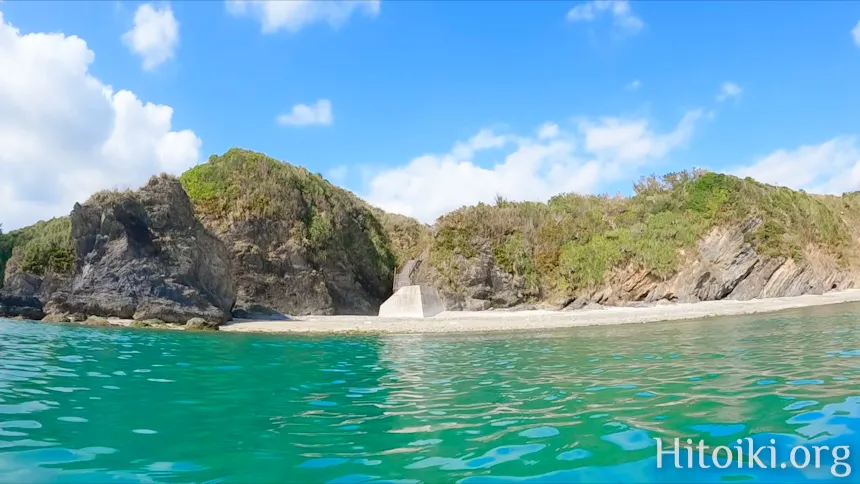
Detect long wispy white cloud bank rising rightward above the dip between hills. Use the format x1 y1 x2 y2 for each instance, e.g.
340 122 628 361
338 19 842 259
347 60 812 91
364 111 702 223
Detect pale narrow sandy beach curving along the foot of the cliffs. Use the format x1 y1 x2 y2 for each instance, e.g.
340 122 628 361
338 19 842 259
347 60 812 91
220 289 860 333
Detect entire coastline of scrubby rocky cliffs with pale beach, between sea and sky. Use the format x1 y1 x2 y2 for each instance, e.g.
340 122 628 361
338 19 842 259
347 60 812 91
0 153 860 332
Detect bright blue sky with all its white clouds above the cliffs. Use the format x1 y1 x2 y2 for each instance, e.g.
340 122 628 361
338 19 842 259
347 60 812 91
0 0 860 228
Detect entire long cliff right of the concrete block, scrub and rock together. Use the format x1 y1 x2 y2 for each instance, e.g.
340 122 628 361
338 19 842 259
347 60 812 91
408 173 860 310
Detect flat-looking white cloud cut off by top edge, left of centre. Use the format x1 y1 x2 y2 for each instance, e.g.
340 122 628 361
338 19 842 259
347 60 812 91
227 0 379 34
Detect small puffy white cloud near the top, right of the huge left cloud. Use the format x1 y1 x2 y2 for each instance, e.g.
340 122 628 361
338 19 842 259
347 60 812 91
122 3 179 70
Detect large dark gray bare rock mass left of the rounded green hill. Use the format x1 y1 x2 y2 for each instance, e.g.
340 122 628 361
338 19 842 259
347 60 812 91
45 176 236 323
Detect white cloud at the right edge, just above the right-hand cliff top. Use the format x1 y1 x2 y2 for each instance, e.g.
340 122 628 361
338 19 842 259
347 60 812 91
728 136 860 194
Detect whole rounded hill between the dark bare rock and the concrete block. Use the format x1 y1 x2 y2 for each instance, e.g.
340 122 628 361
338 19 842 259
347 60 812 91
181 149 395 315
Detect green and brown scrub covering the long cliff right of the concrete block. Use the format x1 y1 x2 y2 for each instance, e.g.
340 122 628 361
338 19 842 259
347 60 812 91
430 171 860 298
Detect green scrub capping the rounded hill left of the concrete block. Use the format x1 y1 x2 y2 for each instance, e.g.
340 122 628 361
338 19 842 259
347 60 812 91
180 148 396 295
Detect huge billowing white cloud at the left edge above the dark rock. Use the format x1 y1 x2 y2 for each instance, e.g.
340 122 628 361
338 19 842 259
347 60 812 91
0 12 201 229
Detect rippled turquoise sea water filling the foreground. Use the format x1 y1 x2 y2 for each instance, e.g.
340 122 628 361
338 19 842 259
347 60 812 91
0 305 860 484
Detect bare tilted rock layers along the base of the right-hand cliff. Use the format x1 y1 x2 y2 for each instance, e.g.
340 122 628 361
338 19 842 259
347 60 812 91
418 218 860 311
